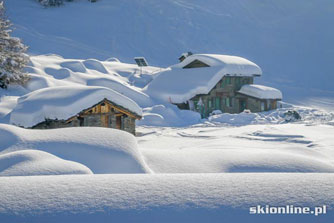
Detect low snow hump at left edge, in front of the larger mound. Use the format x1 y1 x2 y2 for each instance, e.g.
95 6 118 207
0 150 92 176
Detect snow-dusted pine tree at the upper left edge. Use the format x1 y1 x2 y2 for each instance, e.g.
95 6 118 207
0 1 28 88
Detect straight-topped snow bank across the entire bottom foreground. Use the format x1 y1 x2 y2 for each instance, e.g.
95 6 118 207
0 174 334 223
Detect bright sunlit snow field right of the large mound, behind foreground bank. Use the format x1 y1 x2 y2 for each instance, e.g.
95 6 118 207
138 122 334 173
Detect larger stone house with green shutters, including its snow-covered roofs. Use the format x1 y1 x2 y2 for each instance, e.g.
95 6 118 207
147 54 282 118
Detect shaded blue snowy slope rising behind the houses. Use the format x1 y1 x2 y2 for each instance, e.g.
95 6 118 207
5 0 334 108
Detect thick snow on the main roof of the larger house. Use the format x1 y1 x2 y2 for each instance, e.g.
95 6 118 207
146 54 262 103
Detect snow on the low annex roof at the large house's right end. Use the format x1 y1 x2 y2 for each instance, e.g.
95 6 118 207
238 84 283 99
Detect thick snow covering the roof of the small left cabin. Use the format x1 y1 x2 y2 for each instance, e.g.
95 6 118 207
10 85 142 127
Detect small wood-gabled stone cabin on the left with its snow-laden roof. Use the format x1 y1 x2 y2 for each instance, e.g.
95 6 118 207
10 86 142 134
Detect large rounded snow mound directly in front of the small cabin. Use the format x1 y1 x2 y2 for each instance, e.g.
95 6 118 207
0 124 150 173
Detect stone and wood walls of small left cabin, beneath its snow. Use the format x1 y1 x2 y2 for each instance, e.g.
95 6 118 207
32 99 141 135
